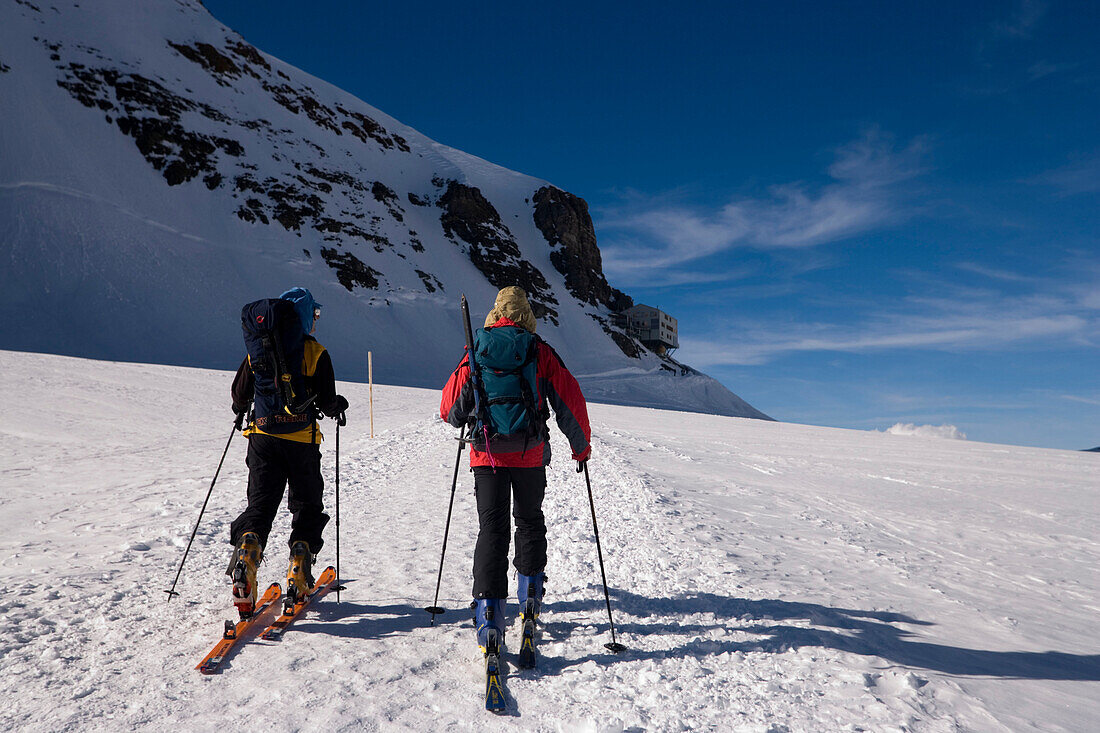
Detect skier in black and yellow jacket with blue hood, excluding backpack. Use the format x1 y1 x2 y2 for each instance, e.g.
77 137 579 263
227 287 348 616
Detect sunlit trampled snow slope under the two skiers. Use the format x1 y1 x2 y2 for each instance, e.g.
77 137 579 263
0 352 1100 733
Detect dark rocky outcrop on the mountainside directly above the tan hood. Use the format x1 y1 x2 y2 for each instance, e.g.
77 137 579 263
438 180 559 326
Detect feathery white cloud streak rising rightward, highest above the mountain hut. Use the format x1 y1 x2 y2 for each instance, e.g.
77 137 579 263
597 129 927 284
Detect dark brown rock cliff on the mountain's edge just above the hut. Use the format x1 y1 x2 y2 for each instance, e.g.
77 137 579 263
534 186 634 313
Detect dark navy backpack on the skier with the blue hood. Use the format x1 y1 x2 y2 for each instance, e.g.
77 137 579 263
241 298 316 434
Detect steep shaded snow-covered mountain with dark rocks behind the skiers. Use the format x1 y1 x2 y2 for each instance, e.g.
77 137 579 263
0 0 767 417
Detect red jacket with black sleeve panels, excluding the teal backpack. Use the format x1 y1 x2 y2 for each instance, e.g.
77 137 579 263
439 318 592 468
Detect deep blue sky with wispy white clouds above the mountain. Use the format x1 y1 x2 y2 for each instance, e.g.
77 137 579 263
205 0 1100 448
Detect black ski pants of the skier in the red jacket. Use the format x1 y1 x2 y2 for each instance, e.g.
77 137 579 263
474 466 547 598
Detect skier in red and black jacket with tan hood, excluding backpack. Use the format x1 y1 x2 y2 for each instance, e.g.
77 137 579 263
439 287 592 652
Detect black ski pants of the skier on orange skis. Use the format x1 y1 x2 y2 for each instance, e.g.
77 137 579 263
229 434 329 555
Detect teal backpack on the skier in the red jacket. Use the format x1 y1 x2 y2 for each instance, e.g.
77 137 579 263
474 326 542 440
